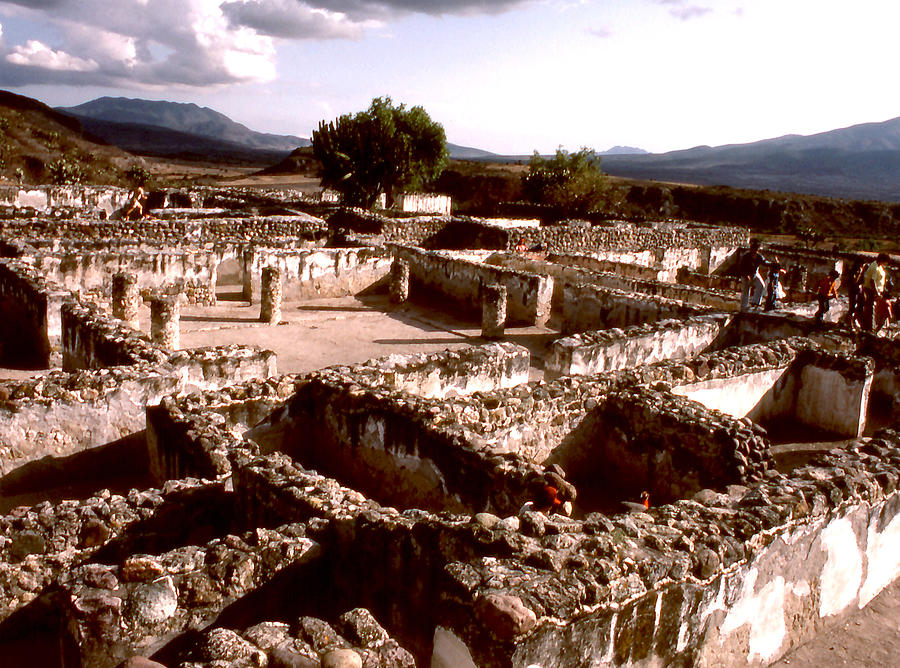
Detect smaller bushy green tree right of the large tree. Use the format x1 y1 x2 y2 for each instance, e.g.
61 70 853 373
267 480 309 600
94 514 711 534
522 148 608 215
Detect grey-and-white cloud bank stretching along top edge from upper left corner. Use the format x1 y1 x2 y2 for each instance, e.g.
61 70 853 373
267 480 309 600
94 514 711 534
0 0 535 88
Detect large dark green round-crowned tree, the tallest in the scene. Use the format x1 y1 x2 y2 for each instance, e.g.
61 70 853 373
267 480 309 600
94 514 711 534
312 97 447 209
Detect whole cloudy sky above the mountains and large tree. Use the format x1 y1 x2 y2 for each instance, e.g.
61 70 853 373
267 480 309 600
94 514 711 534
0 0 900 153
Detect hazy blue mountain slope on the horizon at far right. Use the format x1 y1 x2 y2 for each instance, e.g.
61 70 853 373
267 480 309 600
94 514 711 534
603 118 900 202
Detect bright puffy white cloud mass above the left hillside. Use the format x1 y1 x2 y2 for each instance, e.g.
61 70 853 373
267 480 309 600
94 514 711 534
0 0 275 88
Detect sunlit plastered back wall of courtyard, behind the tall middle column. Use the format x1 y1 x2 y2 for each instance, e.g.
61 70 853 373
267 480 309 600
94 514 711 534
243 248 392 302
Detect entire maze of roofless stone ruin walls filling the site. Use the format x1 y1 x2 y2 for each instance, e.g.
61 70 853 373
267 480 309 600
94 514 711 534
0 188 900 668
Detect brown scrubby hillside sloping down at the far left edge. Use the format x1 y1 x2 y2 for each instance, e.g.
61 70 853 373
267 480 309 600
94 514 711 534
0 91 135 183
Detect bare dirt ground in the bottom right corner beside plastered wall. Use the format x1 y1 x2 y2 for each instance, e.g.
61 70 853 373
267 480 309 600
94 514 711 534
772 581 900 668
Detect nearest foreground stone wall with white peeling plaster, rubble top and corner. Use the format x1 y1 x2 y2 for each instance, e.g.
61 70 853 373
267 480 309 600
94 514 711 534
236 420 900 668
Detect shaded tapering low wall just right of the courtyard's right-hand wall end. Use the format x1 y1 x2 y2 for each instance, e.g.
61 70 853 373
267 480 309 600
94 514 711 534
562 283 711 334
